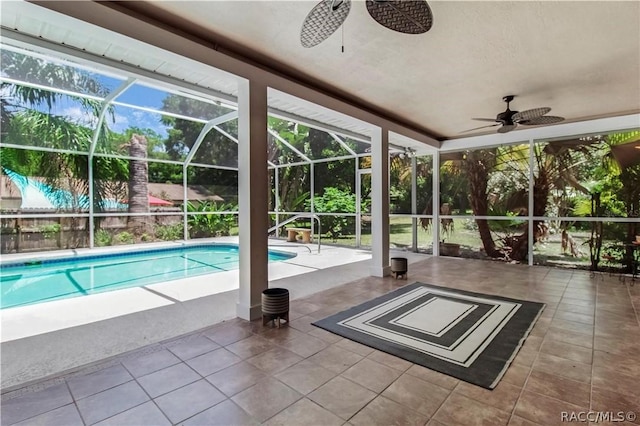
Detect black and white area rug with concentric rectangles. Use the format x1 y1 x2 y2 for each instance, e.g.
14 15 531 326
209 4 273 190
313 283 545 389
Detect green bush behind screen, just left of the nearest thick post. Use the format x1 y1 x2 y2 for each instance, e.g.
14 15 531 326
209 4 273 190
187 202 238 238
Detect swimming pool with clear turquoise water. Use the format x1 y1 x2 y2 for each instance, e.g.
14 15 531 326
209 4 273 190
0 243 295 309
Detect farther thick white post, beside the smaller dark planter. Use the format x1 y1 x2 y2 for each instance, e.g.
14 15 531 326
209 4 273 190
371 128 390 277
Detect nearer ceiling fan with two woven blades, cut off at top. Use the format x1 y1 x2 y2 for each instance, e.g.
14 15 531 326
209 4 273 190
300 0 433 47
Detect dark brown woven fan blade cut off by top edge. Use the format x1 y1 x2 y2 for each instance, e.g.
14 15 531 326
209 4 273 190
367 0 433 34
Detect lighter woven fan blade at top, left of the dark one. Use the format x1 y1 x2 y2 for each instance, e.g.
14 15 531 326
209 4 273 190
300 0 351 47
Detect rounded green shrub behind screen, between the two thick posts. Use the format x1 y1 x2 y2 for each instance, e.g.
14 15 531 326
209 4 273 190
307 187 366 240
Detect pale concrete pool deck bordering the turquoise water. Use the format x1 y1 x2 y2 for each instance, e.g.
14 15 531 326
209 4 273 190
0 237 428 392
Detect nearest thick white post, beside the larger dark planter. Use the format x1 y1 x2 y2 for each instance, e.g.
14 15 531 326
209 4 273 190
236 80 269 320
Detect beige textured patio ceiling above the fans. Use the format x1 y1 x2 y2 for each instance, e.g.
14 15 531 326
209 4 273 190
119 1 640 139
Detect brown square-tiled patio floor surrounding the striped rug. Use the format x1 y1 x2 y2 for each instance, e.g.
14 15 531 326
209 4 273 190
2 258 640 426
